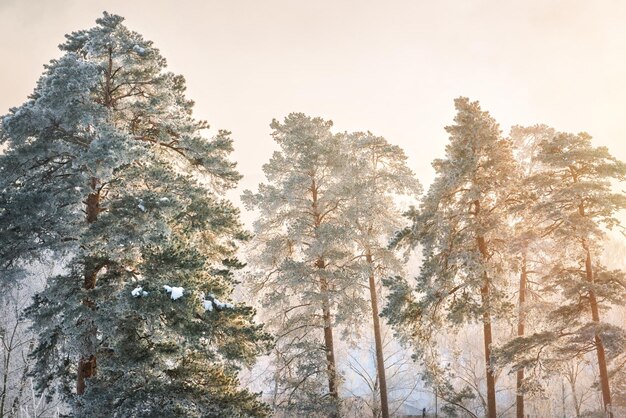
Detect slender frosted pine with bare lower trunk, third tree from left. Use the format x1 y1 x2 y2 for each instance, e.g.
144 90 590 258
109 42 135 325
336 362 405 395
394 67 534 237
344 132 421 418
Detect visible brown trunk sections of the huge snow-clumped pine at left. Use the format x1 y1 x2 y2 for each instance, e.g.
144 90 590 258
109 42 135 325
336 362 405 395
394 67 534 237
76 178 100 395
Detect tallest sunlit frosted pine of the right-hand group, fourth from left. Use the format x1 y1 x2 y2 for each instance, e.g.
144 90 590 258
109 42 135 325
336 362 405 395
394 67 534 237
384 97 518 418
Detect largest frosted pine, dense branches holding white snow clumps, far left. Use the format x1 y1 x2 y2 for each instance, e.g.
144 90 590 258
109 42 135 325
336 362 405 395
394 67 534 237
0 13 268 417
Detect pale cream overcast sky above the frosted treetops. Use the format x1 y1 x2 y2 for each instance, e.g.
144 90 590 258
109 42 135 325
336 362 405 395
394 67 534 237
0 0 626 219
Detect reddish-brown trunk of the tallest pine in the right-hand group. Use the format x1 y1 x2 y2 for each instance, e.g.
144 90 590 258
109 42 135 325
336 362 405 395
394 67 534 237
476 236 497 418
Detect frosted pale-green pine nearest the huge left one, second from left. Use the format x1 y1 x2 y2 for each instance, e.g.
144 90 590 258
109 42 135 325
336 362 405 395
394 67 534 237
242 113 366 416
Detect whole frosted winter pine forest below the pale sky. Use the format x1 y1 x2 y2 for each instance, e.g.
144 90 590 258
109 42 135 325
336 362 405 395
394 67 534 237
0 5 626 418
